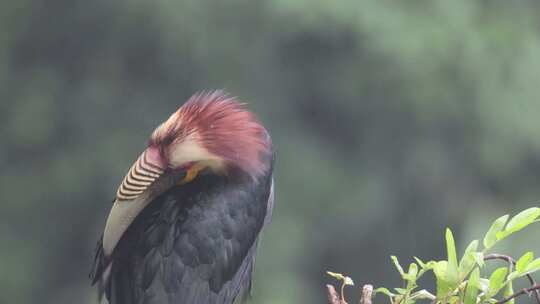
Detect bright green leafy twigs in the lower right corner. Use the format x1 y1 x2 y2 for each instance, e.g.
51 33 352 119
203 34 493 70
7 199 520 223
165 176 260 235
362 207 540 304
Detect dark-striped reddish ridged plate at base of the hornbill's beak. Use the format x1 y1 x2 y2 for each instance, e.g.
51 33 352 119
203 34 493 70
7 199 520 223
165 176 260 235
116 147 166 201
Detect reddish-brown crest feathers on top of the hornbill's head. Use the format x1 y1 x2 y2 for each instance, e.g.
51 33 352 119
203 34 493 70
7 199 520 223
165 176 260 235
151 91 272 176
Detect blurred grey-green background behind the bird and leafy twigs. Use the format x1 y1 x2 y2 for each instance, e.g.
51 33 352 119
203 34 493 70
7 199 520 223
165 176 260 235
0 0 540 304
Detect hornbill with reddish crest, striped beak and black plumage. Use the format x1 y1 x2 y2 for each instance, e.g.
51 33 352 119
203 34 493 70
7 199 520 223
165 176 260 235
90 91 274 304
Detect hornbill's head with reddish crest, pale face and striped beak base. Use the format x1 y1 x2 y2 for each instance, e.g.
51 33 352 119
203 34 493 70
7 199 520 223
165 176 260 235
117 91 271 201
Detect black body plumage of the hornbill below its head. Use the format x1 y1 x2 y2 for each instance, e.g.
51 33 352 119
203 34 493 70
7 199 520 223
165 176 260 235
92 167 273 304
